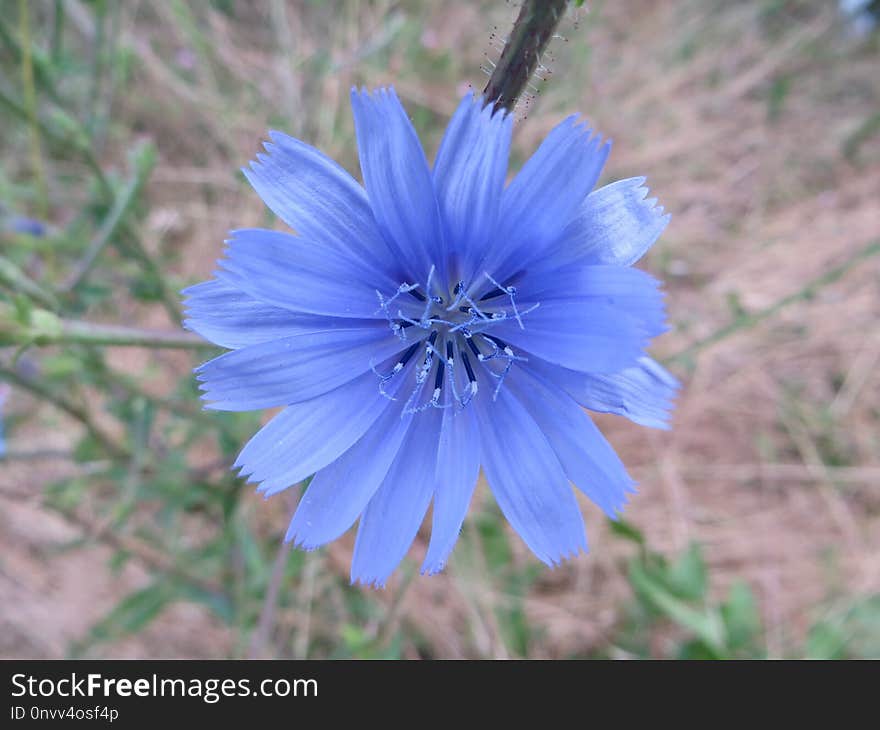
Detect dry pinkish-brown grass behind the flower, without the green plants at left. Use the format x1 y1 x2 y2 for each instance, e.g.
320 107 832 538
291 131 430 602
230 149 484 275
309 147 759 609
0 0 880 657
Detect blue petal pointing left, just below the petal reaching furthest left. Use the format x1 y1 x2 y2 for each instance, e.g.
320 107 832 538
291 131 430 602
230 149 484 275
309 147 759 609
196 322 410 411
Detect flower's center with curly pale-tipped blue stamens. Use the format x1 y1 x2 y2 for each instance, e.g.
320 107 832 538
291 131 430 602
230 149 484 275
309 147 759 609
373 267 538 414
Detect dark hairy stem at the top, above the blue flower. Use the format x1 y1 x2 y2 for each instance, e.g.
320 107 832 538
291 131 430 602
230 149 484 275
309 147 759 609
483 0 567 111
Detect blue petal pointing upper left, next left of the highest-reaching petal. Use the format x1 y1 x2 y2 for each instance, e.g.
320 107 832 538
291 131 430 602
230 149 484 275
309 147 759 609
242 132 392 270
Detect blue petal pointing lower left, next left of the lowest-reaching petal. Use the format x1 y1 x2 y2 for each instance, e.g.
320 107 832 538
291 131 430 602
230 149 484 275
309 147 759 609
284 386 413 550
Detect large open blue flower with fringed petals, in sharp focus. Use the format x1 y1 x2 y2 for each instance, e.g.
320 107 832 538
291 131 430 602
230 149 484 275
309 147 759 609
184 89 677 586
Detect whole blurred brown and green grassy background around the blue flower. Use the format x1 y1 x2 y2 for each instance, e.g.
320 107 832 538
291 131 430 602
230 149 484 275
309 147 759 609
0 0 880 658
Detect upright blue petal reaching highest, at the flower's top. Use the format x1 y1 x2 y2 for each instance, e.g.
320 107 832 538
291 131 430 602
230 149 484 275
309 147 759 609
351 89 446 283
